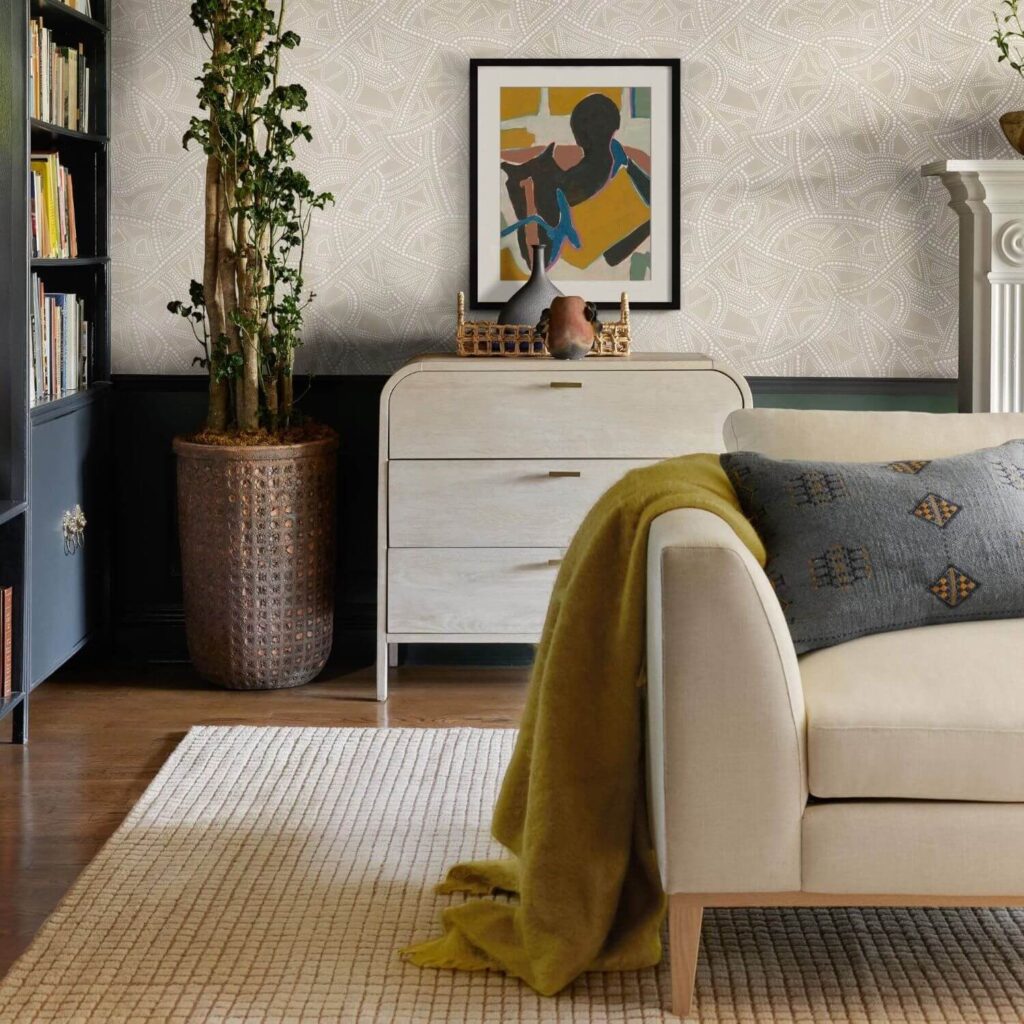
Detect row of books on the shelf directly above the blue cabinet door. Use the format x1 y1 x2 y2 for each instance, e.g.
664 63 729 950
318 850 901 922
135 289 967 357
29 273 92 402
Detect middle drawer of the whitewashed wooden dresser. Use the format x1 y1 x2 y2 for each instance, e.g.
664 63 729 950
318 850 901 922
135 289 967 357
387 459 651 548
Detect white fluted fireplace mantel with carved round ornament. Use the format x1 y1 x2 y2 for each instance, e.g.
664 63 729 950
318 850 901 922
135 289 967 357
921 160 1024 413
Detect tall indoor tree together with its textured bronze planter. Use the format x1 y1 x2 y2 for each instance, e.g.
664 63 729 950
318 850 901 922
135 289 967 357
168 0 338 689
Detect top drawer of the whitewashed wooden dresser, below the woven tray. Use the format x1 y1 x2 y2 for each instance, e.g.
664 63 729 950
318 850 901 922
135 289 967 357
388 360 743 459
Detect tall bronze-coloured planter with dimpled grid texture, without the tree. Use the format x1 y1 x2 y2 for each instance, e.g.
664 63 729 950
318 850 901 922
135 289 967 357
174 438 338 690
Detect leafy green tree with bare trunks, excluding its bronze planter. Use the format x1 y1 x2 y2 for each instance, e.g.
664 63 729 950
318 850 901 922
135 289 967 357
167 0 334 442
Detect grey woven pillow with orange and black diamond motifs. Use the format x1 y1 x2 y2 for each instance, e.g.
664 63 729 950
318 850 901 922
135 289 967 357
721 440 1024 653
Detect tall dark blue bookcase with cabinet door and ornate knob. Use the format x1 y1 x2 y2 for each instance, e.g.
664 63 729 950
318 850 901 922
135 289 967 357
0 0 113 742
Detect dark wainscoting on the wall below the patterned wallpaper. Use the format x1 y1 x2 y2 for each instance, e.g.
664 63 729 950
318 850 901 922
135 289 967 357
112 375 956 666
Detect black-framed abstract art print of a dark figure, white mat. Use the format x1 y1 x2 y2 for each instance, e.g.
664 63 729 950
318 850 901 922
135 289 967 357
469 58 679 309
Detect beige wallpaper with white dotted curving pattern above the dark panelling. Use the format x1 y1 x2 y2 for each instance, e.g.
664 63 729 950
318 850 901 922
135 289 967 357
113 0 1024 377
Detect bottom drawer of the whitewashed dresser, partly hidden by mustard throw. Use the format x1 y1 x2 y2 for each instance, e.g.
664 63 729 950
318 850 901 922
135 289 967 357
387 548 563 639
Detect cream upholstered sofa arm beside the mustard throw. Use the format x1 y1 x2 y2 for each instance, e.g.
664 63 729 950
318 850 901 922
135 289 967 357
647 509 807 893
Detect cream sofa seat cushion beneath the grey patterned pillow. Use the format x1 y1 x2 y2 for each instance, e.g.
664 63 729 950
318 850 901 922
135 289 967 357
800 618 1024 802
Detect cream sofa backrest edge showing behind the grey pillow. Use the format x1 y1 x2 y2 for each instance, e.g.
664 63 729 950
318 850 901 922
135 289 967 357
724 409 1024 462
